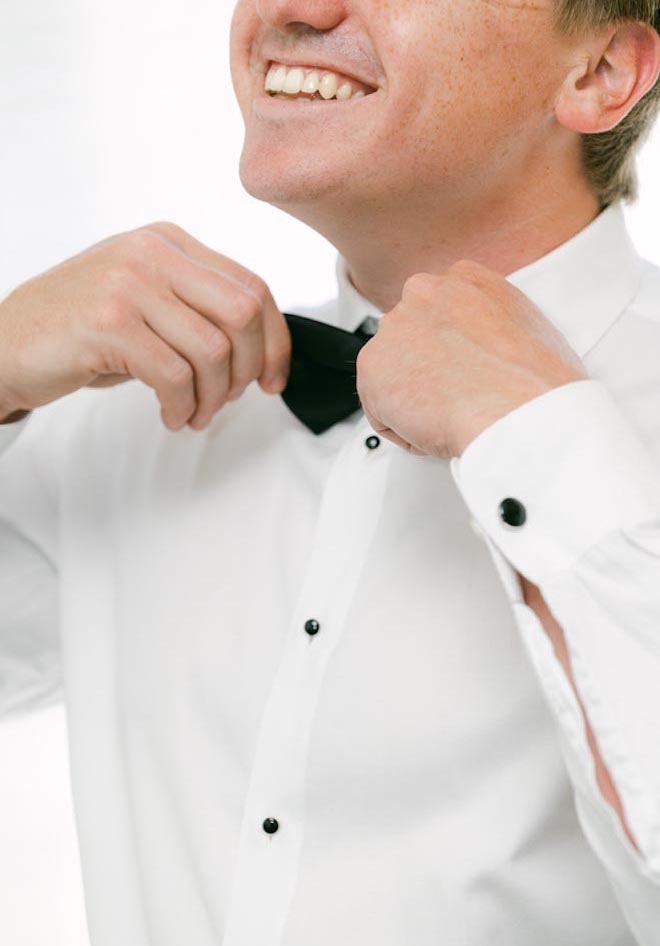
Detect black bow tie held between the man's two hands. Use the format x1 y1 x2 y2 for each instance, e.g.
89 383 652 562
282 312 377 434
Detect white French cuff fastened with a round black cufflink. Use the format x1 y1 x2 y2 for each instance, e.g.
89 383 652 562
450 379 660 585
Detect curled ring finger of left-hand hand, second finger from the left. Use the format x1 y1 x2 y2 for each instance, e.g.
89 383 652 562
142 298 235 430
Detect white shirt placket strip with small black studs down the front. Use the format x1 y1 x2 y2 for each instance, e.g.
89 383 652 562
223 418 392 946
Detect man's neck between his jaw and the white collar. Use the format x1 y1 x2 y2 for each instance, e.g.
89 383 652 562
282 159 600 312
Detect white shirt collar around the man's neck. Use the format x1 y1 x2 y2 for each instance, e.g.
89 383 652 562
336 201 643 358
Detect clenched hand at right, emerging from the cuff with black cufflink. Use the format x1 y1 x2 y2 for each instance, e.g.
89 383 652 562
357 261 587 459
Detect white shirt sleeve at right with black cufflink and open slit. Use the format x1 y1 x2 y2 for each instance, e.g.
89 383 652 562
451 379 660 946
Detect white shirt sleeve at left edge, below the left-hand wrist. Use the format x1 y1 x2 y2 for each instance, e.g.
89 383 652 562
0 411 61 717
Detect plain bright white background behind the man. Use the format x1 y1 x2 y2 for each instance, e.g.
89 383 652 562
0 0 660 946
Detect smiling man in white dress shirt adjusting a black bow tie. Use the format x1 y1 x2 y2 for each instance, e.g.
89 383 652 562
0 0 660 946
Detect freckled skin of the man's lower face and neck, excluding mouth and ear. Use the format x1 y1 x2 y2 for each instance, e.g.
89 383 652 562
231 0 598 310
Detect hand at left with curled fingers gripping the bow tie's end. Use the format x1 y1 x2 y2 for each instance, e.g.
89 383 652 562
0 223 291 430
